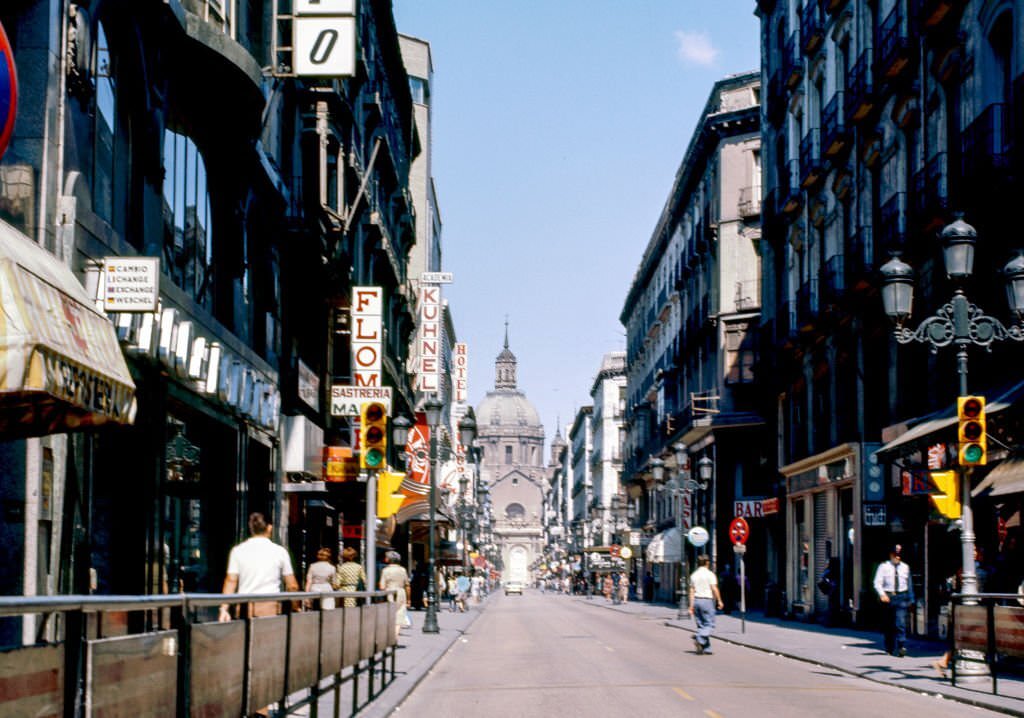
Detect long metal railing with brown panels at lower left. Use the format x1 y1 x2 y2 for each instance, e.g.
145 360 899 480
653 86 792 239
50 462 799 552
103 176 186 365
0 591 399 718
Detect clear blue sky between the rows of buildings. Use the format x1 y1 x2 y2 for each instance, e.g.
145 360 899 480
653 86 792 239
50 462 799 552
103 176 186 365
394 0 760 440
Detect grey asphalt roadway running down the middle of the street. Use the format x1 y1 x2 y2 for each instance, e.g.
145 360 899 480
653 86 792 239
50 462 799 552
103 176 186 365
393 590 998 718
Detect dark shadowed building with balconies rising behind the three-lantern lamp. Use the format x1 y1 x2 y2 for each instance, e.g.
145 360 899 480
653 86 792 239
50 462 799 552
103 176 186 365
757 0 1024 626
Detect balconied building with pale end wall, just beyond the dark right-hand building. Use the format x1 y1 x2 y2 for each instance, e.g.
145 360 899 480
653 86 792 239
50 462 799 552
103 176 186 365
620 73 781 600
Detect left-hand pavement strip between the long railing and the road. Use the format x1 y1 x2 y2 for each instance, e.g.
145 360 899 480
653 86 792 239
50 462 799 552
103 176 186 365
290 594 494 718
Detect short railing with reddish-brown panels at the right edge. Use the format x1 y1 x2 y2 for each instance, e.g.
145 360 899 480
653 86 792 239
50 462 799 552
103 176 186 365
949 593 1024 694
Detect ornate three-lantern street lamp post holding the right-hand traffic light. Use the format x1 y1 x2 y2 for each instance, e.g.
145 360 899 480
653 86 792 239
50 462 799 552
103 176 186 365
881 215 1024 672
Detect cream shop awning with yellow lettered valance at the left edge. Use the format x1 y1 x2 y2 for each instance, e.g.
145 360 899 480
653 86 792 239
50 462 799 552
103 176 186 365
0 221 135 437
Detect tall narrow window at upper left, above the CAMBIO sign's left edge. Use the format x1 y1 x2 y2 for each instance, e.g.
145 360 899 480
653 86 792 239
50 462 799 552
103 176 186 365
92 23 118 221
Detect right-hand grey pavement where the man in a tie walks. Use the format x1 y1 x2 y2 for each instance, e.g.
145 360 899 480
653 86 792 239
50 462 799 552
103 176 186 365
577 597 1024 717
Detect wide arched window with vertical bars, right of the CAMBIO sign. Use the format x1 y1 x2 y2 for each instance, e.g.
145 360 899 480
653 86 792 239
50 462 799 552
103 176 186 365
161 130 213 306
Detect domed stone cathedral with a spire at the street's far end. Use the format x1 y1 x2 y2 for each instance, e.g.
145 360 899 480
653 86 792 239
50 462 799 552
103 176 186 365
476 323 547 583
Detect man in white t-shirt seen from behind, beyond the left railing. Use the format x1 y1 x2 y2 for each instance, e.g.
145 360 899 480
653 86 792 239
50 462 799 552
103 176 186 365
219 512 299 621
